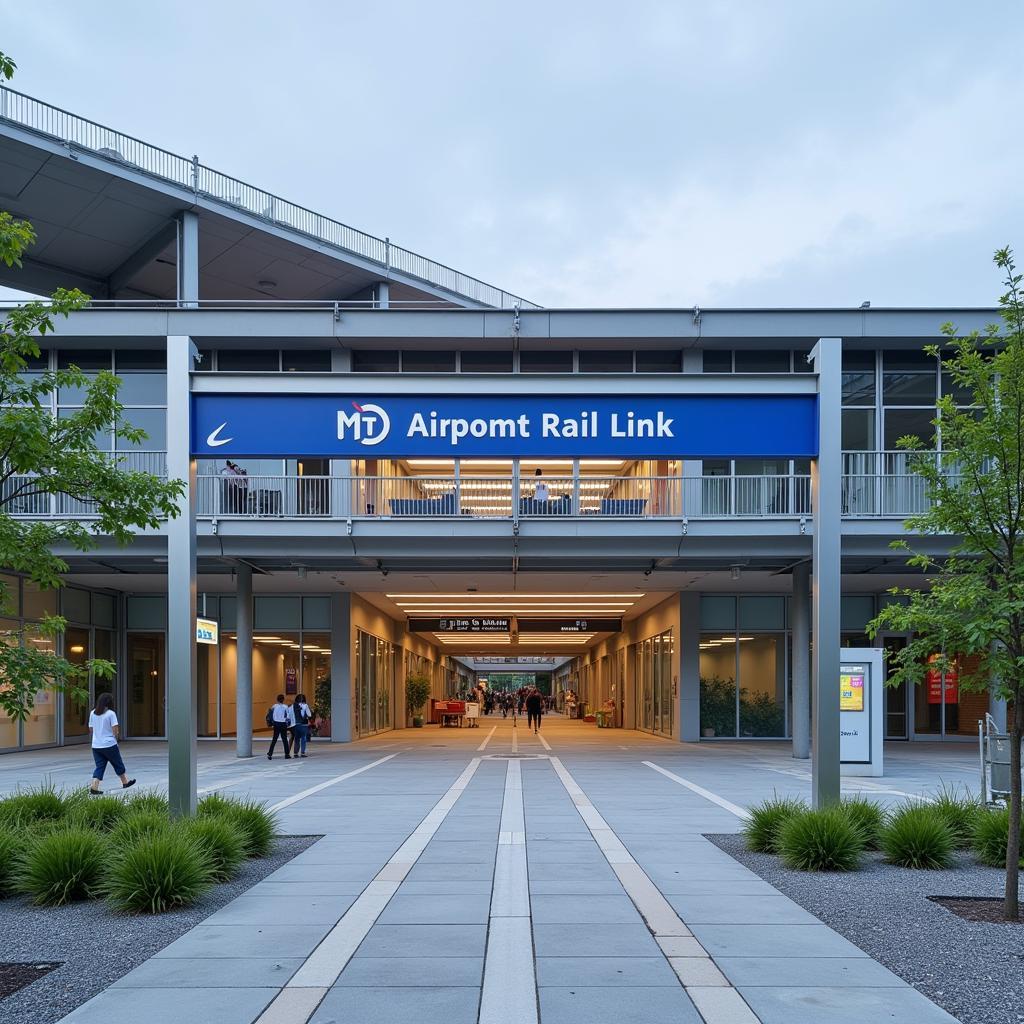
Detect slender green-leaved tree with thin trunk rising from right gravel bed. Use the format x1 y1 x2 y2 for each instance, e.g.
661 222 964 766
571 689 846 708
868 249 1024 921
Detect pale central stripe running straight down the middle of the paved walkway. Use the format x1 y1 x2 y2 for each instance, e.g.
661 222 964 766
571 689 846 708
478 761 539 1024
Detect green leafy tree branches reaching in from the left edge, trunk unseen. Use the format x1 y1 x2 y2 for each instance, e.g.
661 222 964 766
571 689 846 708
0 53 183 720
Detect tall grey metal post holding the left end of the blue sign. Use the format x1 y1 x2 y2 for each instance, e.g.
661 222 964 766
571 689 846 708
167 335 197 815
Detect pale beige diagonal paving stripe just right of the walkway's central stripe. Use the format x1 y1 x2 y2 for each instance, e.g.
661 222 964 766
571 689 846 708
548 757 760 1024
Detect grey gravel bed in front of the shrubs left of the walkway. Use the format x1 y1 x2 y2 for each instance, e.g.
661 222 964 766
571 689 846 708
0 836 319 1024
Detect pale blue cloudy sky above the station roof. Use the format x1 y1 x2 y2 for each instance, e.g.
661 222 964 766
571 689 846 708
0 0 1024 306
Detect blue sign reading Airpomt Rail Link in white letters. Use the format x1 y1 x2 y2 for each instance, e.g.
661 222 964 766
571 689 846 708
191 391 818 459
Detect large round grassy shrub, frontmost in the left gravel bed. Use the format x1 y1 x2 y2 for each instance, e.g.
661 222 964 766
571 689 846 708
104 828 212 913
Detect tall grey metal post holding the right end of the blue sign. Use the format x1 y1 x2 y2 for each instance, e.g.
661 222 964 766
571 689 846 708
811 338 843 807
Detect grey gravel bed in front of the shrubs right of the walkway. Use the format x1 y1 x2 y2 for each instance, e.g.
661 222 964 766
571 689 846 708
708 835 1024 1024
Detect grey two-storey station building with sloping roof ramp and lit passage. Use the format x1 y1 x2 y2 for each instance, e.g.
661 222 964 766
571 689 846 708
0 89 996 750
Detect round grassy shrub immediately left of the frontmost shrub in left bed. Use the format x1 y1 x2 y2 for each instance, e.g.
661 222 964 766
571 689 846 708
15 824 111 906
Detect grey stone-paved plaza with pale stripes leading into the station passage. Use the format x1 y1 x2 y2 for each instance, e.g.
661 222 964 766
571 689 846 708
0 716 978 1024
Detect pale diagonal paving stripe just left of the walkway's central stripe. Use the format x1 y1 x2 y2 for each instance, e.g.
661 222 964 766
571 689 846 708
256 754 481 1024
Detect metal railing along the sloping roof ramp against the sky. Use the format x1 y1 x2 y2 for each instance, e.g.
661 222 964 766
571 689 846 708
0 88 540 309
